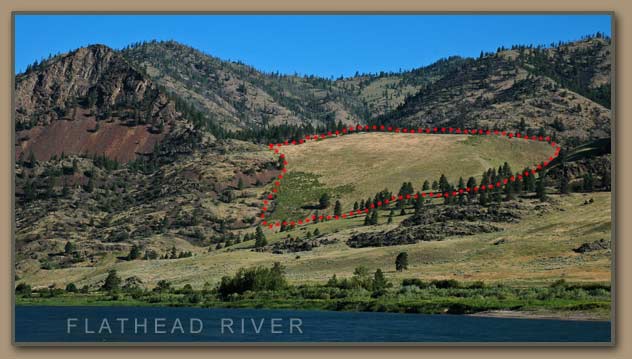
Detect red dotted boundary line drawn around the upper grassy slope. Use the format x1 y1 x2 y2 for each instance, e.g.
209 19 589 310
259 125 561 229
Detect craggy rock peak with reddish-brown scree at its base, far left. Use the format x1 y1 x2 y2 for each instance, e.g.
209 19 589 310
15 45 194 162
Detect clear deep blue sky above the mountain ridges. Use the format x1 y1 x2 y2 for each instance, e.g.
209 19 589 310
15 15 611 77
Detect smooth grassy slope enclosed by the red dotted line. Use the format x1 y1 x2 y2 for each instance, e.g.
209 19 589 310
271 133 553 219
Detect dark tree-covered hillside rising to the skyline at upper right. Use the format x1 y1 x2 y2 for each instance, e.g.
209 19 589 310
374 37 611 142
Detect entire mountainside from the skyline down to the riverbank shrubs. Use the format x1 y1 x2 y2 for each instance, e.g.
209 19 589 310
14 36 611 302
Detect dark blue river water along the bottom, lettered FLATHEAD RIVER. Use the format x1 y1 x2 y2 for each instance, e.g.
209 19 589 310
15 306 611 344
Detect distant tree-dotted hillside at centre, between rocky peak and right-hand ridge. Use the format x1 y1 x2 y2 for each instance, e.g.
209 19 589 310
121 41 464 135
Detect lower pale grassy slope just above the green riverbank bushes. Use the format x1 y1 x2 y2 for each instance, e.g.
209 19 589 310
23 193 611 287
